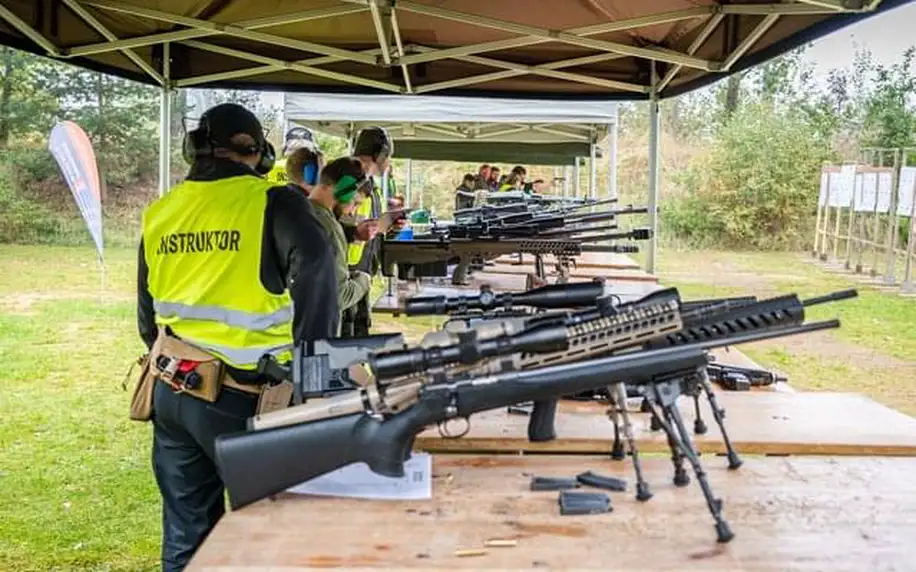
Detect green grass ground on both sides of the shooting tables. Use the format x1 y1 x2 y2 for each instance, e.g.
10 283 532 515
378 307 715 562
0 245 916 571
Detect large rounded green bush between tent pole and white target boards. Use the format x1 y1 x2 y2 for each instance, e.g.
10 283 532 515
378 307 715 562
662 105 830 249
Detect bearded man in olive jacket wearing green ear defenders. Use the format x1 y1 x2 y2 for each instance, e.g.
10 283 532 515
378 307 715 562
309 157 371 335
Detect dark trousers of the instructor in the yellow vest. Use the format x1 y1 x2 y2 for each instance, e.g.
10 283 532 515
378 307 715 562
153 381 258 572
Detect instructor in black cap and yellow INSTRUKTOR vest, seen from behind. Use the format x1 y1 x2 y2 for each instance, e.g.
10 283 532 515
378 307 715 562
134 104 338 572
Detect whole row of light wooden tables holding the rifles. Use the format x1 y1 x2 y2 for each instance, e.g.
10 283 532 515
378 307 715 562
187 253 916 572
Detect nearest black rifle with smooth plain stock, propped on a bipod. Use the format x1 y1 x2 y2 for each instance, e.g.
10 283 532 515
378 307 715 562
215 320 839 542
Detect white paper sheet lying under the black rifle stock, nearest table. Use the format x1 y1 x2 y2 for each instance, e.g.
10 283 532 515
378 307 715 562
287 453 433 500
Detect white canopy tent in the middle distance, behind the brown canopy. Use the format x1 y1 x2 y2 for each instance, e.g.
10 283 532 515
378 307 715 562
284 93 617 209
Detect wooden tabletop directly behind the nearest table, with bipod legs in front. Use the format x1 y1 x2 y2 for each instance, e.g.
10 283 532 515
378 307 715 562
415 391 916 456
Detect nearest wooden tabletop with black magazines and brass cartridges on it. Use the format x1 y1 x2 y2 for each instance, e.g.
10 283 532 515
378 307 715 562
187 456 916 572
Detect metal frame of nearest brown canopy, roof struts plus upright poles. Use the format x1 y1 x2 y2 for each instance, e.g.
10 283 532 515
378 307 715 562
0 0 910 271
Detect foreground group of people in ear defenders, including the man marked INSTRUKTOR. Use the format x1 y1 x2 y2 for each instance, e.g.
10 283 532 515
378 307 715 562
132 104 394 572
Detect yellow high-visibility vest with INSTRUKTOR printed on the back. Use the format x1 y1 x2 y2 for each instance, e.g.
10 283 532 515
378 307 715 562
143 175 293 370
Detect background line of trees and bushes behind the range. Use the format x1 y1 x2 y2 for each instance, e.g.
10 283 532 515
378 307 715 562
0 47 916 248
